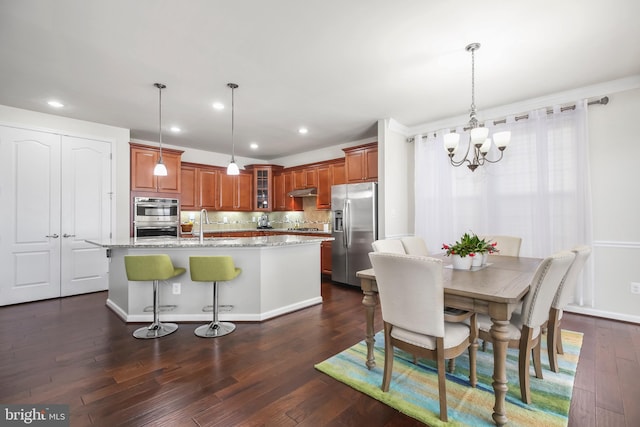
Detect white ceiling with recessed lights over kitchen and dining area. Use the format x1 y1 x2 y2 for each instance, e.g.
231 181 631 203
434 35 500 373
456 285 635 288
0 0 640 160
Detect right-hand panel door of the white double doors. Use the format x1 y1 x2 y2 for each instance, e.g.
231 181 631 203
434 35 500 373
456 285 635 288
60 136 111 296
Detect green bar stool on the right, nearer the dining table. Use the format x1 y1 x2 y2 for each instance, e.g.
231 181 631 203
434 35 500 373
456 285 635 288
189 256 242 338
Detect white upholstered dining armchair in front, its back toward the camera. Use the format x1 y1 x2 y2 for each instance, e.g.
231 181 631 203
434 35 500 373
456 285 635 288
369 252 477 421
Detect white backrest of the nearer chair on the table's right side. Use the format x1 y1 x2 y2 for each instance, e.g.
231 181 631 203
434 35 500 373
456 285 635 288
521 251 576 328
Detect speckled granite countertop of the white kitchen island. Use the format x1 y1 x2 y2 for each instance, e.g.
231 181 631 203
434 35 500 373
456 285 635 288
87 233 334 248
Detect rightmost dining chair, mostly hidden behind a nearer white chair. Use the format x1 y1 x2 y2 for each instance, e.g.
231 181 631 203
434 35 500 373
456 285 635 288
547 246 591 372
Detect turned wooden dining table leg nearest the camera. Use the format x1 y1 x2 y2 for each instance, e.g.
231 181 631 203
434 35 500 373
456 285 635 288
491 319 509 426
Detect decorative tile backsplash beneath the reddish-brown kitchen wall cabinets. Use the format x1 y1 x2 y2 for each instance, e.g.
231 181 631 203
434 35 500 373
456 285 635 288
180 197 331 231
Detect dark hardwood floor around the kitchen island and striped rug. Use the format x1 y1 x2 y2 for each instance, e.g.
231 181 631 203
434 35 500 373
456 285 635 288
0 282 640 427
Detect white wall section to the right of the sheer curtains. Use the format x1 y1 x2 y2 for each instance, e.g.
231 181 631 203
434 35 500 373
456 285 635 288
574 89 640 323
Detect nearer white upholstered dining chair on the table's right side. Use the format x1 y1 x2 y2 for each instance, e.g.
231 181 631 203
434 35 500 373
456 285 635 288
477 251 575 404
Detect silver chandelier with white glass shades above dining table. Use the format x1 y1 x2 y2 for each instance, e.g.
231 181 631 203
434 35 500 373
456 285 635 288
444 43 511 172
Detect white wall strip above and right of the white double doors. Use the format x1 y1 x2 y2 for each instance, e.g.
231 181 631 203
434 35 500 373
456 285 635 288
0 105 130 241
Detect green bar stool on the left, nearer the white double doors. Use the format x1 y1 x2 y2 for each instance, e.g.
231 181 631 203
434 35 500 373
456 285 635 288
124 255 187 339
